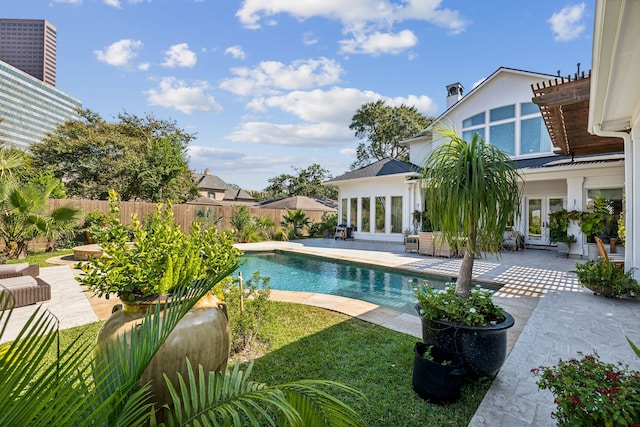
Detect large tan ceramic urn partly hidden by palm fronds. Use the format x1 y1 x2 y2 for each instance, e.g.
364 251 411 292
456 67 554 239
96 294 231 407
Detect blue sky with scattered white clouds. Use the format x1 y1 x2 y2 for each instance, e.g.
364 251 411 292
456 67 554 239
6 0 594 190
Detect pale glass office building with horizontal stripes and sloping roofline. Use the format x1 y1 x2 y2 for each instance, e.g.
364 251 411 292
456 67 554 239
0 61 82 149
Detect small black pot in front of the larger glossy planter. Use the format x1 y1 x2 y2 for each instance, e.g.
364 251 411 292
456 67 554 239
412 342 466 403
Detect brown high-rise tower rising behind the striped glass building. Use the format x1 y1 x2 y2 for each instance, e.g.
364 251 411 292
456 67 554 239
0 18 57 86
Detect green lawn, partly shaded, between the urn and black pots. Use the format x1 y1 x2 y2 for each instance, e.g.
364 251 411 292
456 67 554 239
17 302 490 426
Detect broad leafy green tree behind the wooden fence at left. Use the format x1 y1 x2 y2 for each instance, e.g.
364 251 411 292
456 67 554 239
31 110 198 202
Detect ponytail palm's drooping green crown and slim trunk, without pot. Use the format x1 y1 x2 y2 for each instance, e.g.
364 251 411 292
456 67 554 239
422 128 521 298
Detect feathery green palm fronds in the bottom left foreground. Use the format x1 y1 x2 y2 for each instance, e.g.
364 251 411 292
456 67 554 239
0 272 362 426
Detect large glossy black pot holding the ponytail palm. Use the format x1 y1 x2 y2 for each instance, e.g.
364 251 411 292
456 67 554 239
416 303 514 376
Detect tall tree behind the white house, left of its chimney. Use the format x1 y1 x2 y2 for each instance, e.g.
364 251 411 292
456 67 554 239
349 100 433 170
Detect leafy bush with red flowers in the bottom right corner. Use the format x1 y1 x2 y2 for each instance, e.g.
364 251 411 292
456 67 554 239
531 346 640 426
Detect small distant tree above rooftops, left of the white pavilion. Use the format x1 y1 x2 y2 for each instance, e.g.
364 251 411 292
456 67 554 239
264 163 338 199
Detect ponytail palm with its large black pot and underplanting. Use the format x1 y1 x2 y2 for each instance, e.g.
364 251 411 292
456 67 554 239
418 128 521 375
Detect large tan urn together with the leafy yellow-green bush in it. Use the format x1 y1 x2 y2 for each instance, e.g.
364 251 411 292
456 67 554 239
78 193 239 412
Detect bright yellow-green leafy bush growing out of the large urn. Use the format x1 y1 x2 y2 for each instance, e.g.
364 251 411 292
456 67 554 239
78 194 239 300
